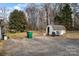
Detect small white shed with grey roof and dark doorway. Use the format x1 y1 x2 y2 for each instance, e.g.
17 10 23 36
46 25 66 35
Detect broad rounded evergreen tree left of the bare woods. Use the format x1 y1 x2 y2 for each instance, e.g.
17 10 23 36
9 10 27 32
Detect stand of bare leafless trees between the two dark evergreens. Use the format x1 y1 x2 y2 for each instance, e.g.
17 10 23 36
26 3 59 30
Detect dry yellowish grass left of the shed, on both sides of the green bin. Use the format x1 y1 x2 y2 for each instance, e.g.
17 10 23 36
7 31 43 39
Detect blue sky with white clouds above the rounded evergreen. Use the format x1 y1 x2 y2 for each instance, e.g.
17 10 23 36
0 3 27 17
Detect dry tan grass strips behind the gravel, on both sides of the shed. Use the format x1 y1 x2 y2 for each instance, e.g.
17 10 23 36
7 31 79 39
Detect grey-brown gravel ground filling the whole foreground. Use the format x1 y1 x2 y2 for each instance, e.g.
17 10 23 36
0 32 79 56
